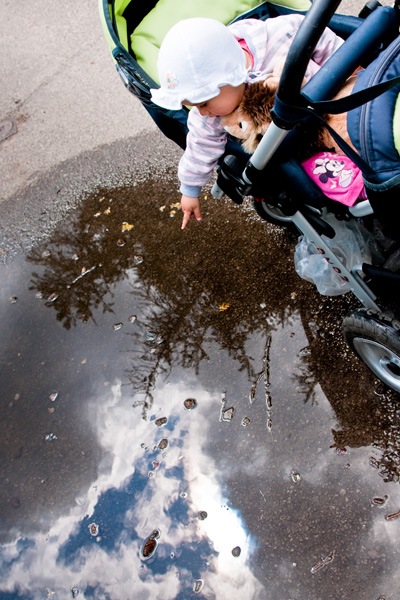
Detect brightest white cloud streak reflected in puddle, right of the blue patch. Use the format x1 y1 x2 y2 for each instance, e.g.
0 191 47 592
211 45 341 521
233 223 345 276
172 389 263 600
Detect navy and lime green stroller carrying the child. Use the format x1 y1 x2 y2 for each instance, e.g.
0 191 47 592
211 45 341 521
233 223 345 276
99 0 400 393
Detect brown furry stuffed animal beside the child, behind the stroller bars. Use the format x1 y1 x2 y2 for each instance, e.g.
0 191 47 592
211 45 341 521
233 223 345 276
222 76 357 160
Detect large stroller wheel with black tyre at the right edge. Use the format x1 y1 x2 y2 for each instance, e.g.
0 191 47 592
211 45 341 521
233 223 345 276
342 308 400 393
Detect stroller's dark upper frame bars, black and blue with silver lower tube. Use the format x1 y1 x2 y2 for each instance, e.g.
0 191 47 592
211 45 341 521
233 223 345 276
243 0 399 175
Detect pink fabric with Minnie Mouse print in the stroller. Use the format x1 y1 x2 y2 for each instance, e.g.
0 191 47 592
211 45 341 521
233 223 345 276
302 152 366 206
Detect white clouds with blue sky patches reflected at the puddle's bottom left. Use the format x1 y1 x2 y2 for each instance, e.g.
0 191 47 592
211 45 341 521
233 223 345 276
0 382 261 600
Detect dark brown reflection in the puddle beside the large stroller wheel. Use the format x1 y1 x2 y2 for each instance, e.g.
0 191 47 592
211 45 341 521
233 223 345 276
295 284 400 481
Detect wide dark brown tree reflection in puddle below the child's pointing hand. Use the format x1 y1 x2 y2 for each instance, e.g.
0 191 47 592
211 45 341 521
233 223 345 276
29 182 299 401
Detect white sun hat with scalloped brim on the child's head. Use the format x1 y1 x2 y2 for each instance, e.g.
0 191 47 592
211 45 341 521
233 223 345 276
151 17 248 110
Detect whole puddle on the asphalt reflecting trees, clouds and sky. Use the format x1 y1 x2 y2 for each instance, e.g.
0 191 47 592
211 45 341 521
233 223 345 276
0 183 400 600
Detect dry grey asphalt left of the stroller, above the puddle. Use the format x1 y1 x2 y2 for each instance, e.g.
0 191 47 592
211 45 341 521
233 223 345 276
0 0 184 260
